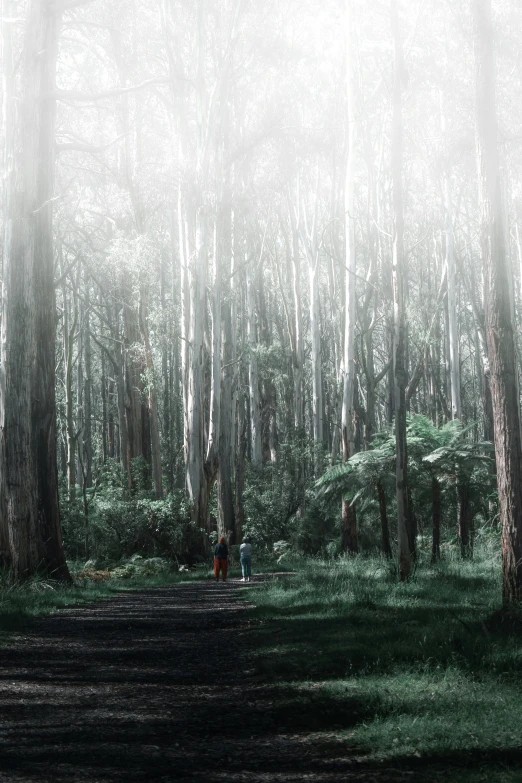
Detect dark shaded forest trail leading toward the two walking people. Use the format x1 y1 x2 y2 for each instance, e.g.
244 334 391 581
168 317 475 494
0 581 412 783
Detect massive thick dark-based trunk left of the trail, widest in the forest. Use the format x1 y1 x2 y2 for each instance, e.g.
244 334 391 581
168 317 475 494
0 0 70 580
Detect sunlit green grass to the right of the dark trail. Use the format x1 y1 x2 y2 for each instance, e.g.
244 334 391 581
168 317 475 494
243 548 522 783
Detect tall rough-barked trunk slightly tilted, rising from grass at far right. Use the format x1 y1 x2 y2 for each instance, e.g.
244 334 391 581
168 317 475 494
473 0 522 603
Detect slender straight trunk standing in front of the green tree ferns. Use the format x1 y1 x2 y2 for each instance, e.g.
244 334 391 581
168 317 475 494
391 0 411 579
